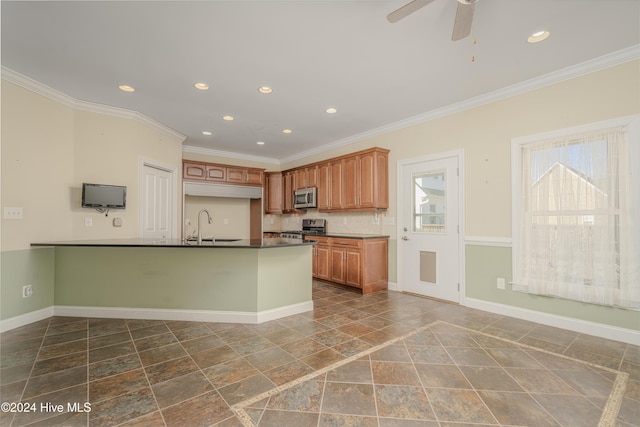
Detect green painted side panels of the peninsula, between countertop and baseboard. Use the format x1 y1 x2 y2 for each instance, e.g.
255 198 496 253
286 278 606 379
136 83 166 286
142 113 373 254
55 246 311 312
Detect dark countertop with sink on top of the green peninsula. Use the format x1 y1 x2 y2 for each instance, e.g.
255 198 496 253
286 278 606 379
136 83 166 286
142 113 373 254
31 237 315 249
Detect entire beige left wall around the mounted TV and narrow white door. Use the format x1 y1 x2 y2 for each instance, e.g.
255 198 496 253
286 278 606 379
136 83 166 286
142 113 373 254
1 80 182 251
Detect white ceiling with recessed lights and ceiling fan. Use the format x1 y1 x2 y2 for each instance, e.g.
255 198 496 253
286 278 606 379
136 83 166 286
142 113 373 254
1 0 640 161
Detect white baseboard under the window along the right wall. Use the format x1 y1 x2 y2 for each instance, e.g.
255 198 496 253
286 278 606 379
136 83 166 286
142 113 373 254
465 298 640 345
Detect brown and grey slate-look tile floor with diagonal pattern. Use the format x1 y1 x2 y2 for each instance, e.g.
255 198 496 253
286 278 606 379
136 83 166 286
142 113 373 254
0 282 640 427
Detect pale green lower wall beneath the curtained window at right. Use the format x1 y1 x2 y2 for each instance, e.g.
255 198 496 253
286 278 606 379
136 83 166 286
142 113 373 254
465 245 640 330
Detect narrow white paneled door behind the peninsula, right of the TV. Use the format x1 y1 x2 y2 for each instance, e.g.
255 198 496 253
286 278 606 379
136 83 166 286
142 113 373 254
142 164 173 239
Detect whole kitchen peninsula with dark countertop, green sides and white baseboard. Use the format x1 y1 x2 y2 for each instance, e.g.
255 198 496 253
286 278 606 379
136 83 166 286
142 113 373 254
32 239 315 323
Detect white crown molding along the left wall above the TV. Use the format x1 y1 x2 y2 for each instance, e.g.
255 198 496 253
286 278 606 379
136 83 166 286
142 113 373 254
2 66 187 143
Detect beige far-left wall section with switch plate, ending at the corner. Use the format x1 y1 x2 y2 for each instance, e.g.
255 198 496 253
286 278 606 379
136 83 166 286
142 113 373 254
1 80 75 251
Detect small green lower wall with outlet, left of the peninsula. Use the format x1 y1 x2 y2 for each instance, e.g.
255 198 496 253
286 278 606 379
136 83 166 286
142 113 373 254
0 248 55 320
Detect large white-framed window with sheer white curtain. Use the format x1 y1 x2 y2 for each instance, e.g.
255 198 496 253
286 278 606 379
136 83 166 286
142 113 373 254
512 116 640 309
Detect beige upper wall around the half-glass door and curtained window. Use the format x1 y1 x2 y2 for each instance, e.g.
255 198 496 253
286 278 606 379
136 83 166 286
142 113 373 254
283 61 640 241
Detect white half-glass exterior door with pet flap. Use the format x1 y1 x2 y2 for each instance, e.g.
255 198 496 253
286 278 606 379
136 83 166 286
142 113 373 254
398 155 461 303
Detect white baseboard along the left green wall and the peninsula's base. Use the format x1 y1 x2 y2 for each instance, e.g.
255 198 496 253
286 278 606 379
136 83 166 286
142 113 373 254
0 301 313 332
